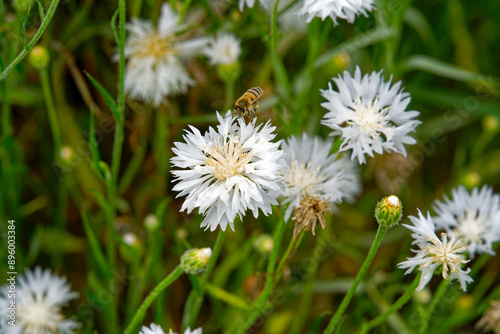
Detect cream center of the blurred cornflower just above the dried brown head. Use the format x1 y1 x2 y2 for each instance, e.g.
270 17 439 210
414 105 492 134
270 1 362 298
284 158 328 196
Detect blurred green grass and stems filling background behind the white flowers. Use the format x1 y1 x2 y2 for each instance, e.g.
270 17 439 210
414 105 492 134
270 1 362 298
0 0 500 333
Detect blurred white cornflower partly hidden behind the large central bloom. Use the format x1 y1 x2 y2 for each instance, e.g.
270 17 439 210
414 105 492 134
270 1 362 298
279 133 361 221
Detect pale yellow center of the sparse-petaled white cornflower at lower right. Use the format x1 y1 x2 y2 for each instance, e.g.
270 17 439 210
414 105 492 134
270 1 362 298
425 233 469 279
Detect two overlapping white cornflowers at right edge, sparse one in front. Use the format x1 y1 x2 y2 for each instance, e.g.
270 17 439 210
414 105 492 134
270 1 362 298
398 186 500 291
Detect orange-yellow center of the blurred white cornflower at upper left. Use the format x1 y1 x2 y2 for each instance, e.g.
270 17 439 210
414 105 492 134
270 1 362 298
132 32 177 63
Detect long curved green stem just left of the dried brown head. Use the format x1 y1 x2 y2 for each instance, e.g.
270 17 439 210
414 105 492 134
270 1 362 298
236 214 286 334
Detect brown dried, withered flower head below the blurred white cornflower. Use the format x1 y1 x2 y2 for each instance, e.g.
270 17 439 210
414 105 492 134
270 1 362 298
292 195 332 239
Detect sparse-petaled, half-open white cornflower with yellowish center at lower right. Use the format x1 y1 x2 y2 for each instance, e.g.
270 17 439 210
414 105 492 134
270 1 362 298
398 210 473 291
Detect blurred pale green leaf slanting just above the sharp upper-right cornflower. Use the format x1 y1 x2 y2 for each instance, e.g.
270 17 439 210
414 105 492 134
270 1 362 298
314 27 396 69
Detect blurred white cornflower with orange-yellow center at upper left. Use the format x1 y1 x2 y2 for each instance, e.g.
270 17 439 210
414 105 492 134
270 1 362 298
123 3 207 106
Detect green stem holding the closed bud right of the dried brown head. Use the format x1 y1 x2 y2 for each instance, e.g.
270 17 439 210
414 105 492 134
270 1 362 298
323 224 389 334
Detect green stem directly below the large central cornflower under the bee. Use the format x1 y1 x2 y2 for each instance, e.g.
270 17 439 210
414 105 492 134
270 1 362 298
182 230 226 327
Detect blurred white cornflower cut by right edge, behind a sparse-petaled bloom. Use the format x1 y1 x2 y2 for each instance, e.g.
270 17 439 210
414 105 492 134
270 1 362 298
434 186 500 258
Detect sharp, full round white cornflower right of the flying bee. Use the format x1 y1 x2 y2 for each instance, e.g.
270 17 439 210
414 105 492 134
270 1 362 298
321 67 421 164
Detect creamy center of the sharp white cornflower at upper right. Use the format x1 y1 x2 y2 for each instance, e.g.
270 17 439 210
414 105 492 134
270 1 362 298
347 96 391 139
